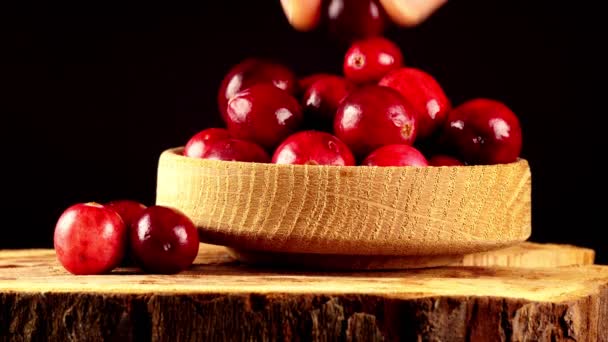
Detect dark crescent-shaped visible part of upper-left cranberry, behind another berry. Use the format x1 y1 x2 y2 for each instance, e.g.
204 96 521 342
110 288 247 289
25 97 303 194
217 58 298 121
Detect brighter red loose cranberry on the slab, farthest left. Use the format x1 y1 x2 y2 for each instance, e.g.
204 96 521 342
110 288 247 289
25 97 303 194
54 203 127 274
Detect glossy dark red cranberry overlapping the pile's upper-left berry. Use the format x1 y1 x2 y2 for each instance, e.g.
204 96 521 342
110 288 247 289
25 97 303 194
227 83 303 150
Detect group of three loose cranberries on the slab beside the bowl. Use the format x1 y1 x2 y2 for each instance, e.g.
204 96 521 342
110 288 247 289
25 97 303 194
54 200 199 275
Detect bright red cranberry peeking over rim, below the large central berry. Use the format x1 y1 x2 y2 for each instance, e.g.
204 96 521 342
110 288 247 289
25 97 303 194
361 144 429 166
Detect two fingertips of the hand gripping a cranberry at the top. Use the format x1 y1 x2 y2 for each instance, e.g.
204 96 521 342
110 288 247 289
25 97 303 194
281 0 447 31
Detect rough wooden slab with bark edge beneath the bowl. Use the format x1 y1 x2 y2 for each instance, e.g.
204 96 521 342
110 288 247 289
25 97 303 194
0 244 608 341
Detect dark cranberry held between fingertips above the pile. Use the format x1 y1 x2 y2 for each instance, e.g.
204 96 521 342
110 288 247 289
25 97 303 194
321 0 390 42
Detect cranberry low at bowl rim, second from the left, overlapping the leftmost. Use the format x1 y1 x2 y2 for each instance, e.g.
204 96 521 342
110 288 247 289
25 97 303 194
202 139 270 163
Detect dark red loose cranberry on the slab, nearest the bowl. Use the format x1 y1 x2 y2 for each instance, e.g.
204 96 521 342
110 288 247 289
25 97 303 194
130 206 199 274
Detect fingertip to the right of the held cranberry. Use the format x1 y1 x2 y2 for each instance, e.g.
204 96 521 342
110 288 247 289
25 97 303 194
380 0 447 26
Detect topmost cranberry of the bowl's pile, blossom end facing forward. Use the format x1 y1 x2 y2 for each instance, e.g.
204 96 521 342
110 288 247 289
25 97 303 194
343 37 403 83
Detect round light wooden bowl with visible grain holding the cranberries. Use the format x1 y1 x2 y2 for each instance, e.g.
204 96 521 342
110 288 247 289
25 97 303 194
156 148 531 269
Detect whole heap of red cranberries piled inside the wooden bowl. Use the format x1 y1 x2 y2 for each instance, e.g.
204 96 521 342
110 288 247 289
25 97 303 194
183 37 522 167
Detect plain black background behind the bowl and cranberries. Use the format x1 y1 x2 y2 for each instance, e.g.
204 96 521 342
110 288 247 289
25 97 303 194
0 0 608 263
